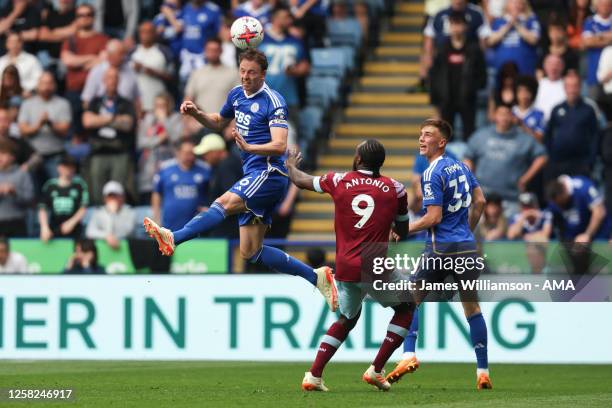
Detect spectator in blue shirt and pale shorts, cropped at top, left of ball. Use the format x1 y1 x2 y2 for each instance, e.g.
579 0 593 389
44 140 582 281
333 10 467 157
179 0 222 82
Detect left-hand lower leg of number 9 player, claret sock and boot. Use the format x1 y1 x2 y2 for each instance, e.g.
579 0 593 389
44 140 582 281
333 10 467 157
302 309 361 391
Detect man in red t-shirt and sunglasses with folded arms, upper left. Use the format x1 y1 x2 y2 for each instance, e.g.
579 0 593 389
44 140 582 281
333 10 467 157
61 4 108 133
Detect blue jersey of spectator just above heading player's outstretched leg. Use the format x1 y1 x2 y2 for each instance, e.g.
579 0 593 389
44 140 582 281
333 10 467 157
153 159 211 231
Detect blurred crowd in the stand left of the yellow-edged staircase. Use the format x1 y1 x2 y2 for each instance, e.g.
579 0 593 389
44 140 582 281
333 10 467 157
0 0 381 247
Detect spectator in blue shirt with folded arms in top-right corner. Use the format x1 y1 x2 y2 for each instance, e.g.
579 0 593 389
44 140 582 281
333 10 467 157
582 0 612 98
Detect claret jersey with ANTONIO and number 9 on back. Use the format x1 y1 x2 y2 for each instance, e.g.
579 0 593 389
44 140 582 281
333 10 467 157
314 170 408 282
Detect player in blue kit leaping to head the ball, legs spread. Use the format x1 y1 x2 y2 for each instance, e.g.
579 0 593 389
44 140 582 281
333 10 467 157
144 49 338 311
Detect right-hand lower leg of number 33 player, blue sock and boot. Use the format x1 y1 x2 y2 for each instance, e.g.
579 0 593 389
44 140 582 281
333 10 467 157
459 291 493 390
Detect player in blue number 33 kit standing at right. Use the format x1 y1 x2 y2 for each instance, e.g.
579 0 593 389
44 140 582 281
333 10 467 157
387 119 493 389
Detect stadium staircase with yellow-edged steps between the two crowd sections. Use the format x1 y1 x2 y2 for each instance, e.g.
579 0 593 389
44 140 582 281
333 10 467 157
287 0 433 253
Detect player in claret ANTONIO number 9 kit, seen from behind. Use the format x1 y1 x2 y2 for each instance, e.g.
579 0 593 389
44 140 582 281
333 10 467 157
286 140 415 391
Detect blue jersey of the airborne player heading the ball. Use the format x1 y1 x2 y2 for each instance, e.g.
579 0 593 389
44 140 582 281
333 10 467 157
220 84 288 175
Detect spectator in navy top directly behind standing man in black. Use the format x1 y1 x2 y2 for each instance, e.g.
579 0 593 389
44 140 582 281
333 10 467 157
409 0 487 92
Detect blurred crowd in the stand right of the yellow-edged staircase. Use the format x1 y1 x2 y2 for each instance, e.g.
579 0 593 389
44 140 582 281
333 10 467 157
408 0 612 249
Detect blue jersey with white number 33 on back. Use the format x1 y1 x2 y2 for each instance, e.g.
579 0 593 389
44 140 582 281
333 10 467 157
421 155 479 250
